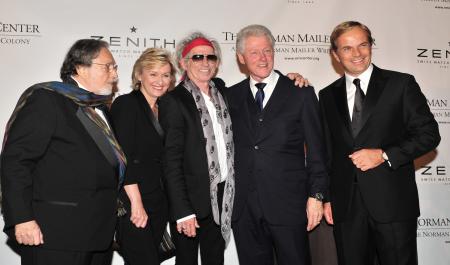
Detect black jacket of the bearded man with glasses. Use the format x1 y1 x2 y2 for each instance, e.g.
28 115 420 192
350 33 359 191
1 83 118 251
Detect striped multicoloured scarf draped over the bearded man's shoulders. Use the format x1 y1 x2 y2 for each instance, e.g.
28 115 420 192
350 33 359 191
3 81 127 188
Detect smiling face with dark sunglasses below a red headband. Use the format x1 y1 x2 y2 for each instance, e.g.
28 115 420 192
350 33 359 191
180 45 218 86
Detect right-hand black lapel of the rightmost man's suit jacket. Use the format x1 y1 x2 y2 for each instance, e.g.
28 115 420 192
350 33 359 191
360 66 387 136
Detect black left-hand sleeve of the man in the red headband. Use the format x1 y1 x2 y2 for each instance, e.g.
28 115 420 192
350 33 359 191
159 94 194 220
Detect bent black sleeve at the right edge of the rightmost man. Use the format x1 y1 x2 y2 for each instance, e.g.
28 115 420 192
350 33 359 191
384 75 441 170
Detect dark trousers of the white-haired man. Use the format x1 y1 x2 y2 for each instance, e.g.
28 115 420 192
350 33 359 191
233 191 310 265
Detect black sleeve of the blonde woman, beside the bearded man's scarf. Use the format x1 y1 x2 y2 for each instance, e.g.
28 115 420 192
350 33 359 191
111 95 140 185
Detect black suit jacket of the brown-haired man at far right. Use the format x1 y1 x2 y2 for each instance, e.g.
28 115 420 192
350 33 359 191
319 66 440 222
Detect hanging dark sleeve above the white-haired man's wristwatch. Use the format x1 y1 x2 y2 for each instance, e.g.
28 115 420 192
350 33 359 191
302 87 328 196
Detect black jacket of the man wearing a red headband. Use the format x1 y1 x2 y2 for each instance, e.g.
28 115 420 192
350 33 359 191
159 83 227 221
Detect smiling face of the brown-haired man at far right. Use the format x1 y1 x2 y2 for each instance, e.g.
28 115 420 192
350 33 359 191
332 27 372 77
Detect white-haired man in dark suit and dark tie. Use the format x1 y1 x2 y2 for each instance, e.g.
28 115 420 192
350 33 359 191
228 25 327 265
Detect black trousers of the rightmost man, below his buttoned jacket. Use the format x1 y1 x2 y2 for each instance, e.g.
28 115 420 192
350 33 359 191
334 183 418 265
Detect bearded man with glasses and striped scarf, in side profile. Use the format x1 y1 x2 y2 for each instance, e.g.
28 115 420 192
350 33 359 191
1 39 125 265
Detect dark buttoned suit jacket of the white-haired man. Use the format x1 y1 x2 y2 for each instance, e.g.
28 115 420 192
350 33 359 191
228 71 327 224
